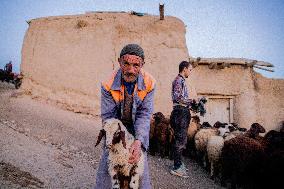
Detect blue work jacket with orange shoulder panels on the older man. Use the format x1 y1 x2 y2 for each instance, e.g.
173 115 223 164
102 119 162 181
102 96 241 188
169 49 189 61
101 69 156 150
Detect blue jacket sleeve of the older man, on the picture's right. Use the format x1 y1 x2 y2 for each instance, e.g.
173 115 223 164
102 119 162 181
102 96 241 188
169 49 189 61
134 88 155 150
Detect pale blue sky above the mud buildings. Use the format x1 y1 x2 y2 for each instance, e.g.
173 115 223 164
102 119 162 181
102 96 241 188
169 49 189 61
0 0 284 79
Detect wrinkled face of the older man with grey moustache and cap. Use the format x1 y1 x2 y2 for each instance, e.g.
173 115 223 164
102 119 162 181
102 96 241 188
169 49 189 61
118 54 144 83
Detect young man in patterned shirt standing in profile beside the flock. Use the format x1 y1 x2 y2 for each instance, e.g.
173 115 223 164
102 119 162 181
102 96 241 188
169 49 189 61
170 61 192 178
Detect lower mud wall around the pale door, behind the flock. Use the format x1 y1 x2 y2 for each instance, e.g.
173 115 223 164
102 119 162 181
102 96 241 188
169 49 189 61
188 65 284 130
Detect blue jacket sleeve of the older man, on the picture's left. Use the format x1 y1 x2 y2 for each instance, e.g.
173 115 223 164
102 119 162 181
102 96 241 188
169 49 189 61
101 86 116 122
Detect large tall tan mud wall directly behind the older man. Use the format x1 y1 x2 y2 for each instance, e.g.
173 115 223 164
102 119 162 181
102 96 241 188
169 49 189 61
21 13 188 115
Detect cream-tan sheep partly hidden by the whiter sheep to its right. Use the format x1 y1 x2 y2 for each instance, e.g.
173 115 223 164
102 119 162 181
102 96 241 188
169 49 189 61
194 128 218 167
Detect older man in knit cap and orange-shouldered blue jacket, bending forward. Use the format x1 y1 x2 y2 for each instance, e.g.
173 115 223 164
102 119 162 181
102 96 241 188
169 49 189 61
95 44 155 189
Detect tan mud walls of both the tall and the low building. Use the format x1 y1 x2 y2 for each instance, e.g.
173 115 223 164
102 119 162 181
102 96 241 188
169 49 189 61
21 13 284 130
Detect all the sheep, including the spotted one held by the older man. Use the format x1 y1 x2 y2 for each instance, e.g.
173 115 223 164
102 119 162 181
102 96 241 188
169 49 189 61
96 112 284 189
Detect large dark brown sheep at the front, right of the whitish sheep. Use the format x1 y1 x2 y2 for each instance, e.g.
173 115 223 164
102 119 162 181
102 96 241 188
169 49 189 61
221 136 265 188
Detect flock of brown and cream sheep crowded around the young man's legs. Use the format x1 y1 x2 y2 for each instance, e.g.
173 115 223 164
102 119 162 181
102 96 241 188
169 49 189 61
149 112 284 188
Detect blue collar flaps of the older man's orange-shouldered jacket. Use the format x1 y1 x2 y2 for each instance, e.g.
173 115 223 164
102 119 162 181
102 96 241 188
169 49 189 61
111 69 146 91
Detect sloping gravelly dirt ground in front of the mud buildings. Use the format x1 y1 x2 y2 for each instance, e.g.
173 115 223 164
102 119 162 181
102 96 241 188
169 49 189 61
0 82 221 189
